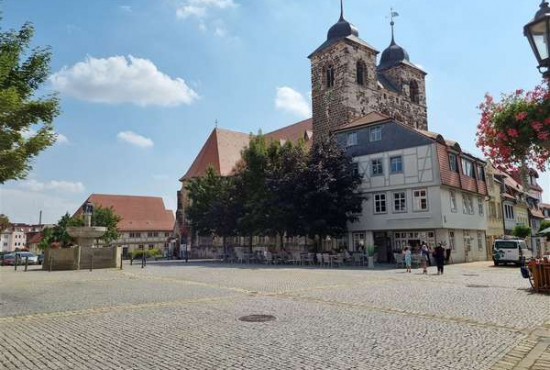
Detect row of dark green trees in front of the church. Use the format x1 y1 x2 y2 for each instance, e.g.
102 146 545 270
186 134 363 251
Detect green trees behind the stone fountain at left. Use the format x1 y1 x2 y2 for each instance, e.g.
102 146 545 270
39 207 121 249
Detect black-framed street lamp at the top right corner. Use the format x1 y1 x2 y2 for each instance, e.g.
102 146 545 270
524 0 550 78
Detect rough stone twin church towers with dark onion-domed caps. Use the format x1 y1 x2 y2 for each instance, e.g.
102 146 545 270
309 0 427 141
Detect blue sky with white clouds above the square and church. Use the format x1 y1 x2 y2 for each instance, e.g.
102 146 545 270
0 0 550 222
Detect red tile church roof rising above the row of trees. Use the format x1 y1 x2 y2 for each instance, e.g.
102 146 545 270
180 119 313 181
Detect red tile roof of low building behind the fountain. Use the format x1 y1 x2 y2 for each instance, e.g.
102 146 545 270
76 194 175 232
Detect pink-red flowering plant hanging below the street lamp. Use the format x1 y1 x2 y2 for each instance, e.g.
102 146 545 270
477 80 550 172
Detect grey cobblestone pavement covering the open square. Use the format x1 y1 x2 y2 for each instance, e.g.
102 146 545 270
0 262 550 370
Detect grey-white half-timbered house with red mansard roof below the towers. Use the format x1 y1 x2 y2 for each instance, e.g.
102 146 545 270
335 112 488 262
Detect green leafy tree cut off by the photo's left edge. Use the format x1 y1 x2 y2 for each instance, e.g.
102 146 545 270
0 23 59 184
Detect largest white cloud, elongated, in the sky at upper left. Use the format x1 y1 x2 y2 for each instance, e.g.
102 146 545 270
50 55 199 106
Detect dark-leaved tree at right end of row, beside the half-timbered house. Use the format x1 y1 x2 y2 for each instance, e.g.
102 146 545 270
296 138 364 248
